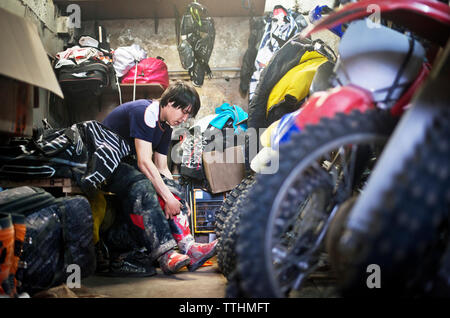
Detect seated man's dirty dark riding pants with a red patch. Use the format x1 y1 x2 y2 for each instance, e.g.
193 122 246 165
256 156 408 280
102 163 187 260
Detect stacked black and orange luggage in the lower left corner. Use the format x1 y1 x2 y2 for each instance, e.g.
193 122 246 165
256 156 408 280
0 186 96 297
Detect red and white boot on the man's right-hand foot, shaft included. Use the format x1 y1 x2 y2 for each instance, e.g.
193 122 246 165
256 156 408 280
171 213 217 272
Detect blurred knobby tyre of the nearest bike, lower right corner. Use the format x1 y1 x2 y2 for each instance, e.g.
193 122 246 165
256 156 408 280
337 111 450 297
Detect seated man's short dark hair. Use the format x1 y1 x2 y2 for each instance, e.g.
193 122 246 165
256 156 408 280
159 81 200 117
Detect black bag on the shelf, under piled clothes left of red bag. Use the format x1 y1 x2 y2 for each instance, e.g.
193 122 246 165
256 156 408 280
58 61 115 99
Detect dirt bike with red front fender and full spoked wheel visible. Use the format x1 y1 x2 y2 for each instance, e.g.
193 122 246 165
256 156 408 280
232 1 450 297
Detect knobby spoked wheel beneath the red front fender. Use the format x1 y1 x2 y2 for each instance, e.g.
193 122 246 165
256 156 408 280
237 110 396 297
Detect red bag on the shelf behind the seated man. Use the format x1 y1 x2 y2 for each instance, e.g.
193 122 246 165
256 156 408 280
121 57 169 89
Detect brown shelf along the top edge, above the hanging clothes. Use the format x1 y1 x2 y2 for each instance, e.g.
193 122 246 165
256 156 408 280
53 0 266 21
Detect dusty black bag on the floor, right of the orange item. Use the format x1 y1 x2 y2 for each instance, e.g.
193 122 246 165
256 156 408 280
0 186 96 295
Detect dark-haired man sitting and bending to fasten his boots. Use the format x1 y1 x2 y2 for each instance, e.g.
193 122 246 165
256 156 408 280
103 82 217 274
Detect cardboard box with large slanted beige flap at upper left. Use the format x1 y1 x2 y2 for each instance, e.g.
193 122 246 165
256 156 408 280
0 9 64 136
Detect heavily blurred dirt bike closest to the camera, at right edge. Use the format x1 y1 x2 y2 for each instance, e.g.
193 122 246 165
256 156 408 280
328 1 450 297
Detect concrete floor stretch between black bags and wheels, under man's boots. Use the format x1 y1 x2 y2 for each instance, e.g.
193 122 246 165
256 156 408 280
81 257 226 298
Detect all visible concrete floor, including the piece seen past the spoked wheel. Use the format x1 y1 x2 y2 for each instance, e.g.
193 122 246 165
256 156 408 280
76 257 339 298
